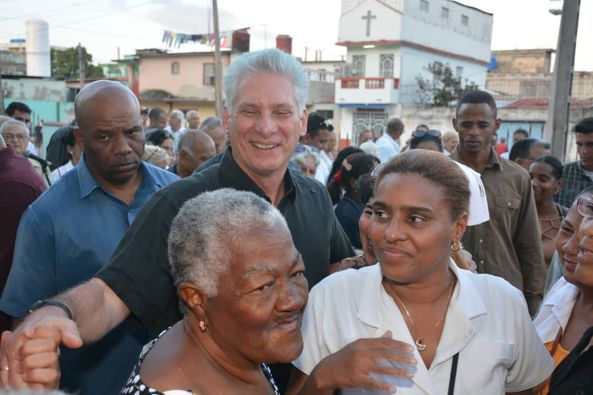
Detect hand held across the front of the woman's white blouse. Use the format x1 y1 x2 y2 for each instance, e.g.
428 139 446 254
303 331 417 393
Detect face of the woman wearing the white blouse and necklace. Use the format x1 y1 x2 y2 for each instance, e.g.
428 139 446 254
369 173 464 283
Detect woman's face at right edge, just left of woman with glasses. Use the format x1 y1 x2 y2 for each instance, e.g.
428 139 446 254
555 205 583 284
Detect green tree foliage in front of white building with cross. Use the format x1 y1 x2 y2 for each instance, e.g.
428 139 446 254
416 62 479 107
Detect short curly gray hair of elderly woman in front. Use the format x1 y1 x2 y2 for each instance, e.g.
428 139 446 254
169 188 289 309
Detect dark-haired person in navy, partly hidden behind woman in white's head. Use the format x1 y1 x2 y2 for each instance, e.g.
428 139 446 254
334 153 379 250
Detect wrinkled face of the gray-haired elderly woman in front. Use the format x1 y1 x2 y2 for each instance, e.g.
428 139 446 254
206 225 308 363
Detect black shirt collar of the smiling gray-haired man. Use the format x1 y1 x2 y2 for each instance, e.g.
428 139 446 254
218 147 296 202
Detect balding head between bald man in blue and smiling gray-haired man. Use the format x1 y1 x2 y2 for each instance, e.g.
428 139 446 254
171 130 216 178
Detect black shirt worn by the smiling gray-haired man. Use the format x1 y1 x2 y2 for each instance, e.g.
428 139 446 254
97 149 354 336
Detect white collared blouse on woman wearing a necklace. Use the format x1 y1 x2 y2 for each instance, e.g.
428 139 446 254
293 262 554 395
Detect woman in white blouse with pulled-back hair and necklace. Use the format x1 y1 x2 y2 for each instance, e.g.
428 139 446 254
288 150 553 394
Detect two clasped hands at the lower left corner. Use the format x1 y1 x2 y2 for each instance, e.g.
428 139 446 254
0 306 82 388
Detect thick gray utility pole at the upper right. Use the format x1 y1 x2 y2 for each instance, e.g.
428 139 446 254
544 0 581 162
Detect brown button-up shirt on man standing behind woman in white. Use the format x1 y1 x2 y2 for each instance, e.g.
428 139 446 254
450 150 546 316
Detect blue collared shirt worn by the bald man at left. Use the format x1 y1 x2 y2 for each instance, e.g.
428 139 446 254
0 156 179 395
